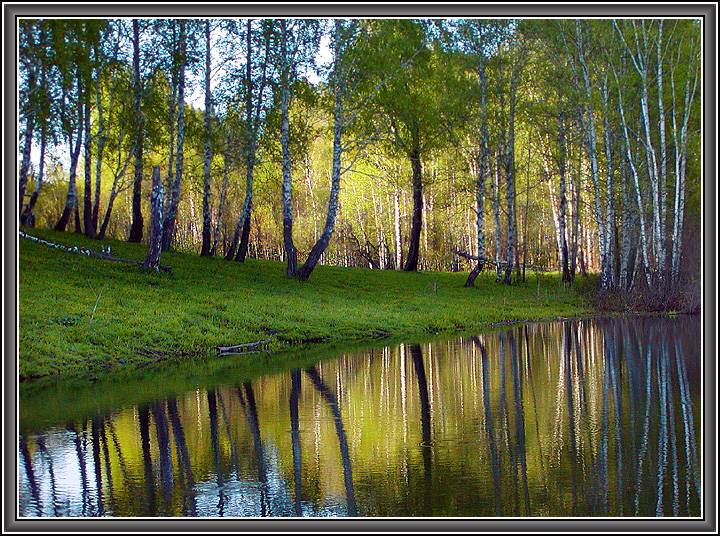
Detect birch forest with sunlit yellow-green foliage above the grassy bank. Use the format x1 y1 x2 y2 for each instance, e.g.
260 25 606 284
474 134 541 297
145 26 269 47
18 19 702 302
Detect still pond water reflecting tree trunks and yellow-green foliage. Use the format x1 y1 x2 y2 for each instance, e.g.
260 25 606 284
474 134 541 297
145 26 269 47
19 318 701 517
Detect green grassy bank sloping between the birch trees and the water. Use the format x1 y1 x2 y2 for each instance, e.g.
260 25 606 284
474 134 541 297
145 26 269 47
20 230 587 379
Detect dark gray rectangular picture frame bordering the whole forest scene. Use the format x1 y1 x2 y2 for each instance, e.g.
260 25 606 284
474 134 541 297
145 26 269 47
3 2 717 532
